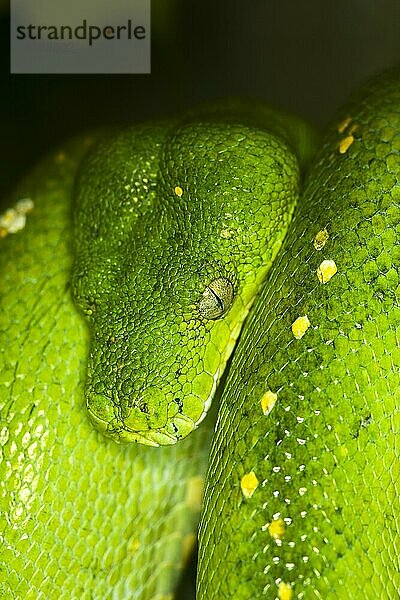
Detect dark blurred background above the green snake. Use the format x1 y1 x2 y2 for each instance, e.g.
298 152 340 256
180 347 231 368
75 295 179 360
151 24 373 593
0 0 400 599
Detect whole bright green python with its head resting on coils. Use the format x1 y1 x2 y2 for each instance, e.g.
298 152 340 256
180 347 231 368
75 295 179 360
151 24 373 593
0 72 400 600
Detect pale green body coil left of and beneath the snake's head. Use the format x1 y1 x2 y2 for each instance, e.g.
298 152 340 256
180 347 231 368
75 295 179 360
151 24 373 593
0 137 216 600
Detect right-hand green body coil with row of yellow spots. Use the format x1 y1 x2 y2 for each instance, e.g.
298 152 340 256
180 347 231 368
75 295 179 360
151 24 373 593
198 70 400 600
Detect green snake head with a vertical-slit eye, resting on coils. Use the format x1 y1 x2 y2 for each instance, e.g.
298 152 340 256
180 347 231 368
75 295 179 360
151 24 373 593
72 113 299 445
